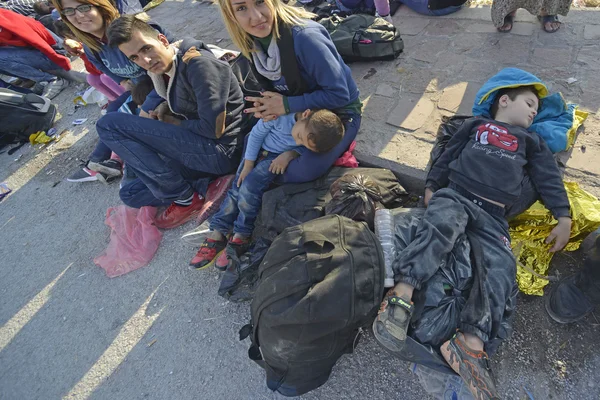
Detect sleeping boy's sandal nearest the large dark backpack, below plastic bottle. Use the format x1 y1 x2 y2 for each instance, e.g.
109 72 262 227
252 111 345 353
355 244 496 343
373 290 414 355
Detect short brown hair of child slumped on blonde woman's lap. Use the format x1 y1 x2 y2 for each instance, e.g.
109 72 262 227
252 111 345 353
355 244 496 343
306 110 344 153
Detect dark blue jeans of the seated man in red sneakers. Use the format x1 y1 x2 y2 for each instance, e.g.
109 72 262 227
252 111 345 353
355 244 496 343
96 112 239 207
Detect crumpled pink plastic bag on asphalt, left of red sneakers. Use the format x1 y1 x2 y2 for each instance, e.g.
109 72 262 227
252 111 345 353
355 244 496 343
94 205 162 278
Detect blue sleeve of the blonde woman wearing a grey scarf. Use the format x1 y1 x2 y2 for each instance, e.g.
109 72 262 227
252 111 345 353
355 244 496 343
288 28 351 112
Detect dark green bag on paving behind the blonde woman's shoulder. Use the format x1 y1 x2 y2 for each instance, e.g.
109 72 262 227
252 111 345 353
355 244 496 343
319 14 404 61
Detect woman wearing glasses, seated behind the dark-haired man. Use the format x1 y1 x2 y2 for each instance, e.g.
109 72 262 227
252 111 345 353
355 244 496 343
52 0 172 182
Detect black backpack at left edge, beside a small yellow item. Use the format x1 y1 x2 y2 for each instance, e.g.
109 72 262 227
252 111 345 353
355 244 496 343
0 89 56 153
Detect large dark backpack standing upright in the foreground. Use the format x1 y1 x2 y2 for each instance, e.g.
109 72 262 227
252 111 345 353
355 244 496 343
240 215 385 396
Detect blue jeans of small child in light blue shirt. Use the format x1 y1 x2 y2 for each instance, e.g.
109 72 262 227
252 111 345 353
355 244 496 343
210 151 279 237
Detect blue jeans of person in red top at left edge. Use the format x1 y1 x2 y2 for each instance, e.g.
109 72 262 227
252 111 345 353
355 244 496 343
0 47 62 82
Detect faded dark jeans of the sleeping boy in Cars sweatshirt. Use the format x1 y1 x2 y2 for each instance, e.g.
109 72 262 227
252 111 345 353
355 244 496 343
392 183 517 342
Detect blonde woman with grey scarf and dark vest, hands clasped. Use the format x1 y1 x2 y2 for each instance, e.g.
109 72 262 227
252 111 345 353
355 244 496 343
219 0 362 183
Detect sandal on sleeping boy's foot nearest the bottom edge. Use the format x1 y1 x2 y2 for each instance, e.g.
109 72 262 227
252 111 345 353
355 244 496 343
440 334 500 400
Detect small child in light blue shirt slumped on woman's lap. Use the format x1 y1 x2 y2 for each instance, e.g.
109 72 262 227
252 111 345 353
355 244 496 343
192 110 344 271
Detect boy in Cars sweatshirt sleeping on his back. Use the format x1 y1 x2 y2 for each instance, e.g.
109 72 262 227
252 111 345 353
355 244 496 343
373 86 571 399
